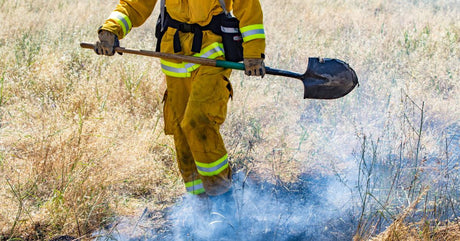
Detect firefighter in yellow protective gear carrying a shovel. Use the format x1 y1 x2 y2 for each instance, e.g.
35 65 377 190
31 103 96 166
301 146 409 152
95 0 265 201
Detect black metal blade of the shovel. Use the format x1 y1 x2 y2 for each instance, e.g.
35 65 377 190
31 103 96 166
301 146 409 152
301 58 358 99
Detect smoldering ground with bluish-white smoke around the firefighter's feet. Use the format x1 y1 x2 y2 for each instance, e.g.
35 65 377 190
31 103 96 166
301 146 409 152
97 172 356 240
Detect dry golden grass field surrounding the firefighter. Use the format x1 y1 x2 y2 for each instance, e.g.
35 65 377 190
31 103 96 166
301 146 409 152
0 0 460 240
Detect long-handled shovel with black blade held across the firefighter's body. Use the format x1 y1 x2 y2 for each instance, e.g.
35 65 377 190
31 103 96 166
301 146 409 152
80 43 358 99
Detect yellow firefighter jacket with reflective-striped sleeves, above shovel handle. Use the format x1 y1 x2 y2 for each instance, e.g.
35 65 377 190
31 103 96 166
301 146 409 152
101 0 265 58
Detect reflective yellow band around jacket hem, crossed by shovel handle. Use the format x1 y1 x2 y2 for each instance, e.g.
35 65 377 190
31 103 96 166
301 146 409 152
160 42 224 78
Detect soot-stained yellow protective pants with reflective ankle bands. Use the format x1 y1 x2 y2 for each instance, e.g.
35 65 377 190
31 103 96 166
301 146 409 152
164 66 233 196
